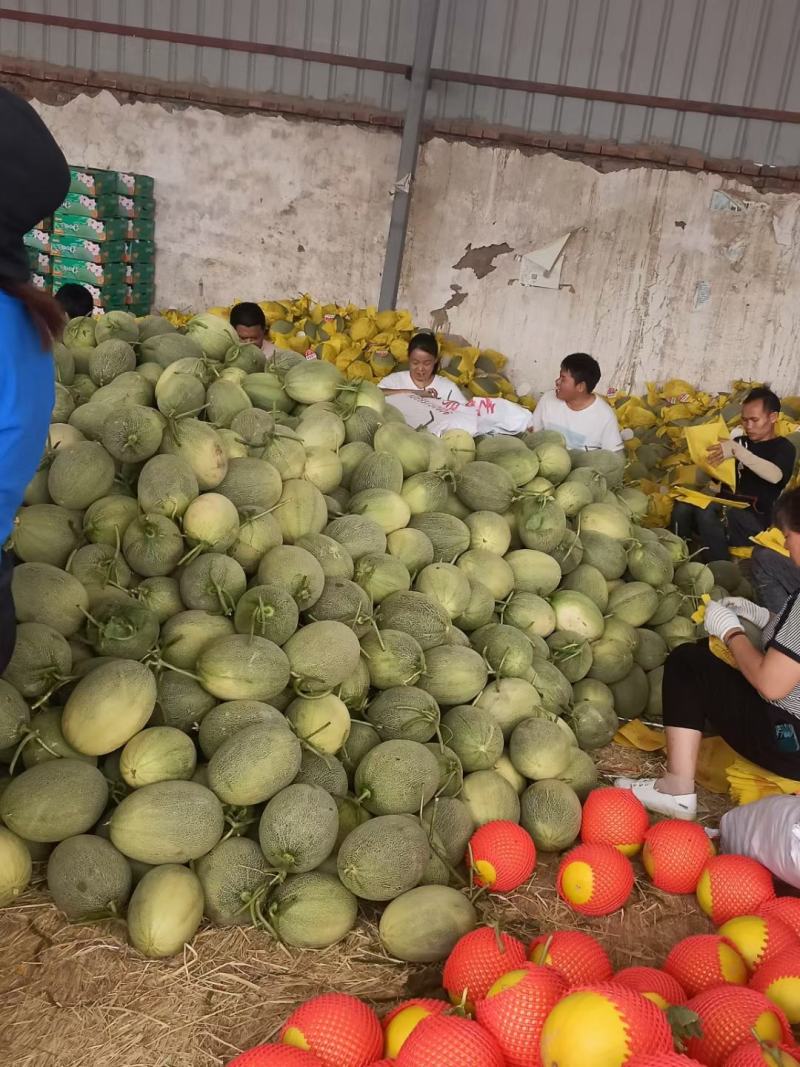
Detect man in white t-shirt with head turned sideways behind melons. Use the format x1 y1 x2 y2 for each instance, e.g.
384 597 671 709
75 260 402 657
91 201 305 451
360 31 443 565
531 352 623 452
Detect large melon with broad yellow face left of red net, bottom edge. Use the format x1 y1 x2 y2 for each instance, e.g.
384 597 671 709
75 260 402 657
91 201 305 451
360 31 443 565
541 983 672 1067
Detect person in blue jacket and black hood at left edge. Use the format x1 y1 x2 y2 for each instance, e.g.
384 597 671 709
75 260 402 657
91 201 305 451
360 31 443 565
0 89 69 672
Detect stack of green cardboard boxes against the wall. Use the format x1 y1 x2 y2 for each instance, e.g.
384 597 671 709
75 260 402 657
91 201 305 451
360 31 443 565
42 166 156 315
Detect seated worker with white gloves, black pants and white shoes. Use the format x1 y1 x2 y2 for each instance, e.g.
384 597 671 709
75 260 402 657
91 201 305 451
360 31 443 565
614 489 800 819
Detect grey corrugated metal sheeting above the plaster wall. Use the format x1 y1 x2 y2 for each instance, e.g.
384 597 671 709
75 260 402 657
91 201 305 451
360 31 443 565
0 0 800 165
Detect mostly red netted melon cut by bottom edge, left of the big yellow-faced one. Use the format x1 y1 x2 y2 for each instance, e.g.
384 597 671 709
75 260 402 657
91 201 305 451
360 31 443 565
396 1015 506 1067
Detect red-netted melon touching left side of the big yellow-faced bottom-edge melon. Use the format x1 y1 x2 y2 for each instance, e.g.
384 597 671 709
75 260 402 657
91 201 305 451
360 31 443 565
476 964 567 1067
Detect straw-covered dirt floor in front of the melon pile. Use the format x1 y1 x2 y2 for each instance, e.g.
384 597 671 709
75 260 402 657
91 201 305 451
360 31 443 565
0 747 726 1067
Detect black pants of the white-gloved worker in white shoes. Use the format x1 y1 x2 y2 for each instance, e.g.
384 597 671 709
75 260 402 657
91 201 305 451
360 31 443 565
662 640 800 779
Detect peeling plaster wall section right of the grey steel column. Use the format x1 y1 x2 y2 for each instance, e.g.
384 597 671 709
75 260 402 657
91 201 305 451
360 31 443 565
402 140 800 394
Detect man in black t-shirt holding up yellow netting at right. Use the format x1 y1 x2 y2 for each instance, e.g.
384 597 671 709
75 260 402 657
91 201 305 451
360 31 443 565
670 386 795 562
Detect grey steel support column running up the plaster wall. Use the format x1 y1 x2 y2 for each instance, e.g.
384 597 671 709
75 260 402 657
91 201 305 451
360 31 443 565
379 0 438 312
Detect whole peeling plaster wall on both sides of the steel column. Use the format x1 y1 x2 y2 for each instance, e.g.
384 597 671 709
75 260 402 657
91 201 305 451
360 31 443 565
32 93 800 394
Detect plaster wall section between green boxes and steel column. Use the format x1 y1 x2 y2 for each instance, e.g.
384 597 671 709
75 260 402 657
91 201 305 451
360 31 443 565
33 92 399 308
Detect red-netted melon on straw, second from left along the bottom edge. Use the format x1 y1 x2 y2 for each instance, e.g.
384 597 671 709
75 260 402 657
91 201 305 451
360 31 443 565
281 993 383 1067
